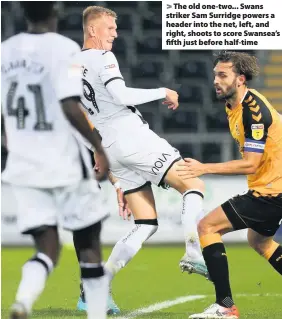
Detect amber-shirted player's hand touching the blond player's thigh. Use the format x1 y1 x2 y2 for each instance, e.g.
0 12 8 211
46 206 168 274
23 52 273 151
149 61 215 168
176 158 206 179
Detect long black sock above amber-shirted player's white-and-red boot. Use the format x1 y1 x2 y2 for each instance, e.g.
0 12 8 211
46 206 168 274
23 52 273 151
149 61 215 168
203 243 234 308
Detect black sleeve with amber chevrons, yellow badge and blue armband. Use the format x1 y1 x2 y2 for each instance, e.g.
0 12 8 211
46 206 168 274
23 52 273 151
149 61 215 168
243 100 272 153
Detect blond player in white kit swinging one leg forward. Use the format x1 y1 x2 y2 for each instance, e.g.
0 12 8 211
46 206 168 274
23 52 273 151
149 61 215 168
77 6 208 314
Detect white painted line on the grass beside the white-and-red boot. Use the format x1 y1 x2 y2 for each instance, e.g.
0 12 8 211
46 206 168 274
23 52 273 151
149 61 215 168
116 295 206 319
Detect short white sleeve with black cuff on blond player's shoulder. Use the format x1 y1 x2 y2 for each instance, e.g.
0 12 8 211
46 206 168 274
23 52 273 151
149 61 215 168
99 51 123 86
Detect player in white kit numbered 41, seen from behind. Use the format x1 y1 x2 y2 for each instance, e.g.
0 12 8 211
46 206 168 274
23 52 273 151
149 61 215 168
1 1 109 319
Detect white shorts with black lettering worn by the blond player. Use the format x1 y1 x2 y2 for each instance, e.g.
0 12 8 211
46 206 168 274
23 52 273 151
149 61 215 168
105 127 181 194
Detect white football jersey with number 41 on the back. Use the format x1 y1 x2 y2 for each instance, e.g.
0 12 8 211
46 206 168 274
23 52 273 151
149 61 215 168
1 32 91 188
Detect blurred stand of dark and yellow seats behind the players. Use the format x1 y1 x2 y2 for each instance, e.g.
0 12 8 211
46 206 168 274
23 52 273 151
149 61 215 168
1 1 282 162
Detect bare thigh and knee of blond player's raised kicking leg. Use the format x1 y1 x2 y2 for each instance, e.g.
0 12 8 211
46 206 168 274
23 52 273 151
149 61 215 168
164 159 205 194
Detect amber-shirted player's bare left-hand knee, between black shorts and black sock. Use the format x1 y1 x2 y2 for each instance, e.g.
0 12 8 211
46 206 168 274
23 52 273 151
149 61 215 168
198 206 233 236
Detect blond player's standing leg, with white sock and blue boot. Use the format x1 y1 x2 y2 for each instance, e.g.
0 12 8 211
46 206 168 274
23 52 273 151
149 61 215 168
74 152 158 314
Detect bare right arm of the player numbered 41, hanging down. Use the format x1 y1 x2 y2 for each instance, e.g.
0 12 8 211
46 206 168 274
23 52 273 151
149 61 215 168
62 98 109 181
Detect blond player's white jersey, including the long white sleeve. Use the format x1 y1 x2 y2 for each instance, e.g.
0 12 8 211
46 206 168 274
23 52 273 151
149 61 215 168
76 49 165 146
